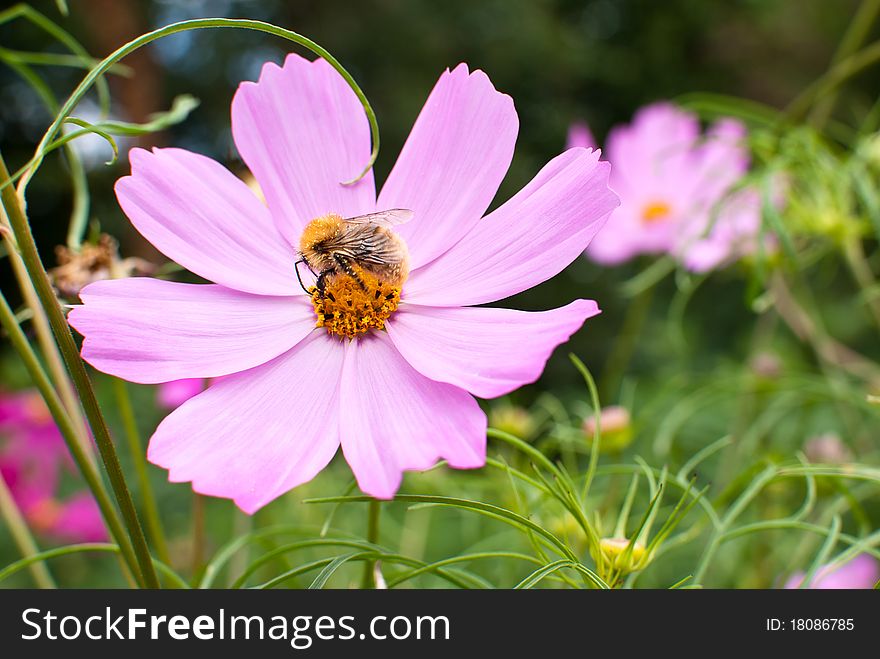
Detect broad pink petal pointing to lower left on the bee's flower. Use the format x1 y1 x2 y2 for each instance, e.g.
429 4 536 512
147 330 344 513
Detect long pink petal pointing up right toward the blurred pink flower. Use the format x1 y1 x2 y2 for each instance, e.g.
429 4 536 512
404 149 618 306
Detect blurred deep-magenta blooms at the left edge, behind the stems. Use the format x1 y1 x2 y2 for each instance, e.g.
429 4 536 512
0 391 107 542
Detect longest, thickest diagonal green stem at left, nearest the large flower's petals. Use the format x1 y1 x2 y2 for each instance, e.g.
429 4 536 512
0 156 159 588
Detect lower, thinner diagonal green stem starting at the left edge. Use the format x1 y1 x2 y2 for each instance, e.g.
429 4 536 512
0 292 137 580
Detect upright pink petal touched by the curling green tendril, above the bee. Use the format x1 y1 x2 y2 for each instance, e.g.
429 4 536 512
232 53 376 245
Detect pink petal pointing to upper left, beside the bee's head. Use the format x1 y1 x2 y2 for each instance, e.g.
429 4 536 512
116 149 302 295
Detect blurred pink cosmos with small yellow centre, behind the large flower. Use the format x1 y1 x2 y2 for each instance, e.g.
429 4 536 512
569 103 761 272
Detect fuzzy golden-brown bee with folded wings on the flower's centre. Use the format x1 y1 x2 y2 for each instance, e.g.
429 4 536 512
294 208 413 297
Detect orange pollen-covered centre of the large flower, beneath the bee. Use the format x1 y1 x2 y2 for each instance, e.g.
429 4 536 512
309 272 400 339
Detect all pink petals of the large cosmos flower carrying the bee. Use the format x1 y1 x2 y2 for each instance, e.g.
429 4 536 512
69 55 618 512
